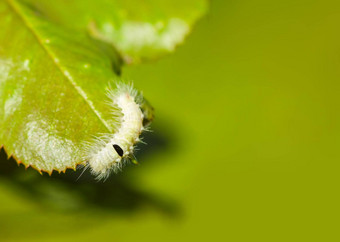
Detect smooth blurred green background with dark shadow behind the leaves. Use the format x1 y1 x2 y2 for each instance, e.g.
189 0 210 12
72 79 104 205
0 0 340 241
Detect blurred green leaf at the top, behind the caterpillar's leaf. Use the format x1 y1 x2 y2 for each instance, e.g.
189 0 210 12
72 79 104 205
20 0 207 63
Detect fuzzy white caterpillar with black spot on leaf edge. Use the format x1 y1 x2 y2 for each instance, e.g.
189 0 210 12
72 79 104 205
85 84 144 180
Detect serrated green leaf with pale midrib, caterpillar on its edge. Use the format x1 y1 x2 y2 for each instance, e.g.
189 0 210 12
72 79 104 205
0 0 146 173
